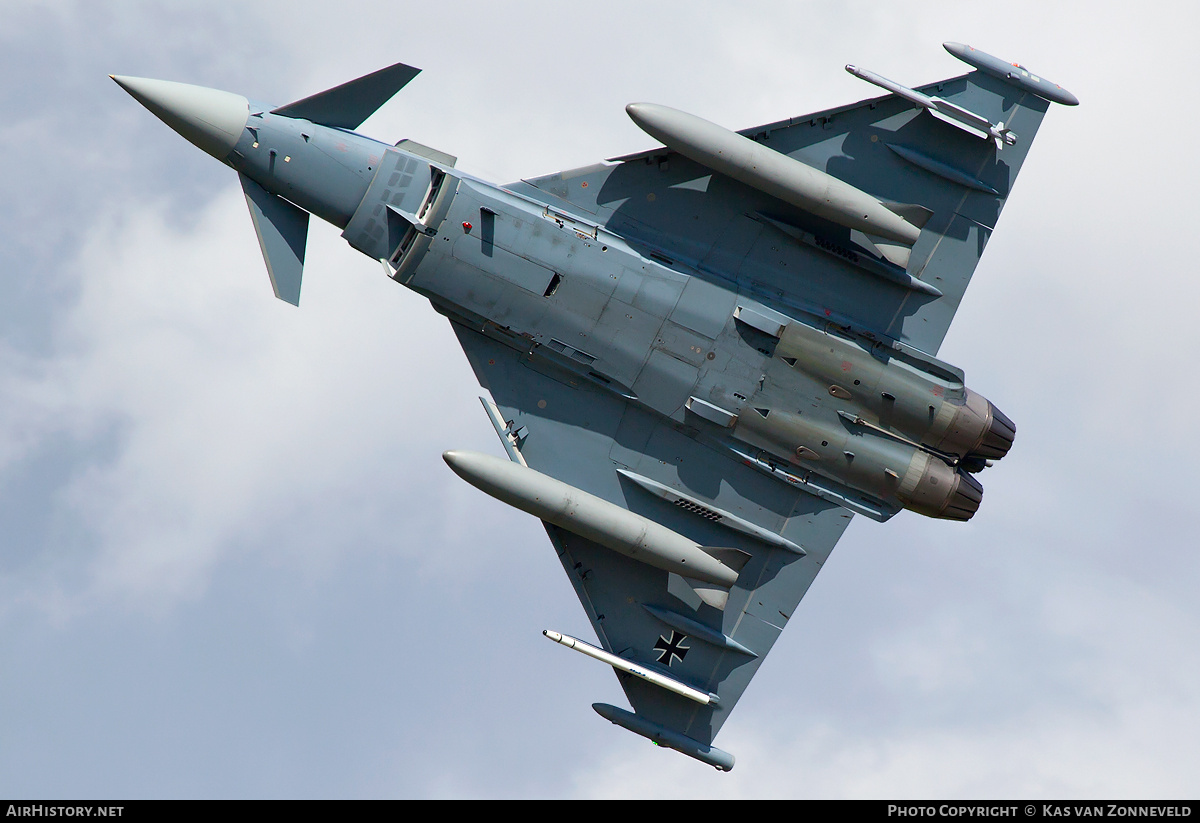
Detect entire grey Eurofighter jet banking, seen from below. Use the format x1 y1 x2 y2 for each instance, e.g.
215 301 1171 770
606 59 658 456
113 43 1079 771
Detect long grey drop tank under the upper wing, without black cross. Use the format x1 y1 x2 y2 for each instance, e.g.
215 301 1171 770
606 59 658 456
625 103 928 253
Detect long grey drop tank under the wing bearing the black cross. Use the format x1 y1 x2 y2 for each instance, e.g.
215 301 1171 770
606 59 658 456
442 451 749 599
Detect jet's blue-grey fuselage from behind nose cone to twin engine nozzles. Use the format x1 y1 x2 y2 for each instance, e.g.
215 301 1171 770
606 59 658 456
224 109 1013 519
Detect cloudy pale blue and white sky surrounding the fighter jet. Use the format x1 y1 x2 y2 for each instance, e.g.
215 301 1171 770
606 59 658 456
0 0 1200 798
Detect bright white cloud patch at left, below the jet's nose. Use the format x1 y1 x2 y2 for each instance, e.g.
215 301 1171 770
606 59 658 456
1 180 501 606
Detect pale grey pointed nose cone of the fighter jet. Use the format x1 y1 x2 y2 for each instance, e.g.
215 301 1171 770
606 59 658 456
109 74 250 161
